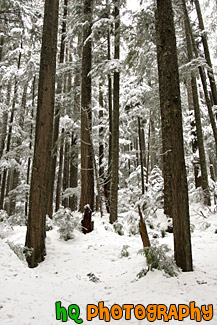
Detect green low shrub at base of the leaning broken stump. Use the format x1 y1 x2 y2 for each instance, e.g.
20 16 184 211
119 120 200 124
139 242 179 277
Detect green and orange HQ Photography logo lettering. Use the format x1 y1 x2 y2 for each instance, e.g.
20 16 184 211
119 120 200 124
55 301 213 324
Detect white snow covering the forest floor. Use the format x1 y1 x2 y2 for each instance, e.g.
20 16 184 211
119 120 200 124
0 205 217 325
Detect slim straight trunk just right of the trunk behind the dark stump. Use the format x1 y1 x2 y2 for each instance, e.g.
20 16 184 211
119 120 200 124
110 0 120 223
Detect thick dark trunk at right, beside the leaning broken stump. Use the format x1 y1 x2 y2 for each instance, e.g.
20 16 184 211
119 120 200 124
156 0 192 271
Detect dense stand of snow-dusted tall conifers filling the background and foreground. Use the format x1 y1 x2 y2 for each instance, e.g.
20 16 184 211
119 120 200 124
0 0 217 271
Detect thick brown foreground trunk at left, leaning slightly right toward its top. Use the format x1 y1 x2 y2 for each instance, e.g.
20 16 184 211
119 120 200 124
26 0 59 267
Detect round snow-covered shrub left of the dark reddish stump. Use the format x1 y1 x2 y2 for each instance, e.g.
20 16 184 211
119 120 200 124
54 208 81 241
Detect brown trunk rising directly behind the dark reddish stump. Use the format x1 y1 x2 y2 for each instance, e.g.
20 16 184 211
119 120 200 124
80 0 94 212
